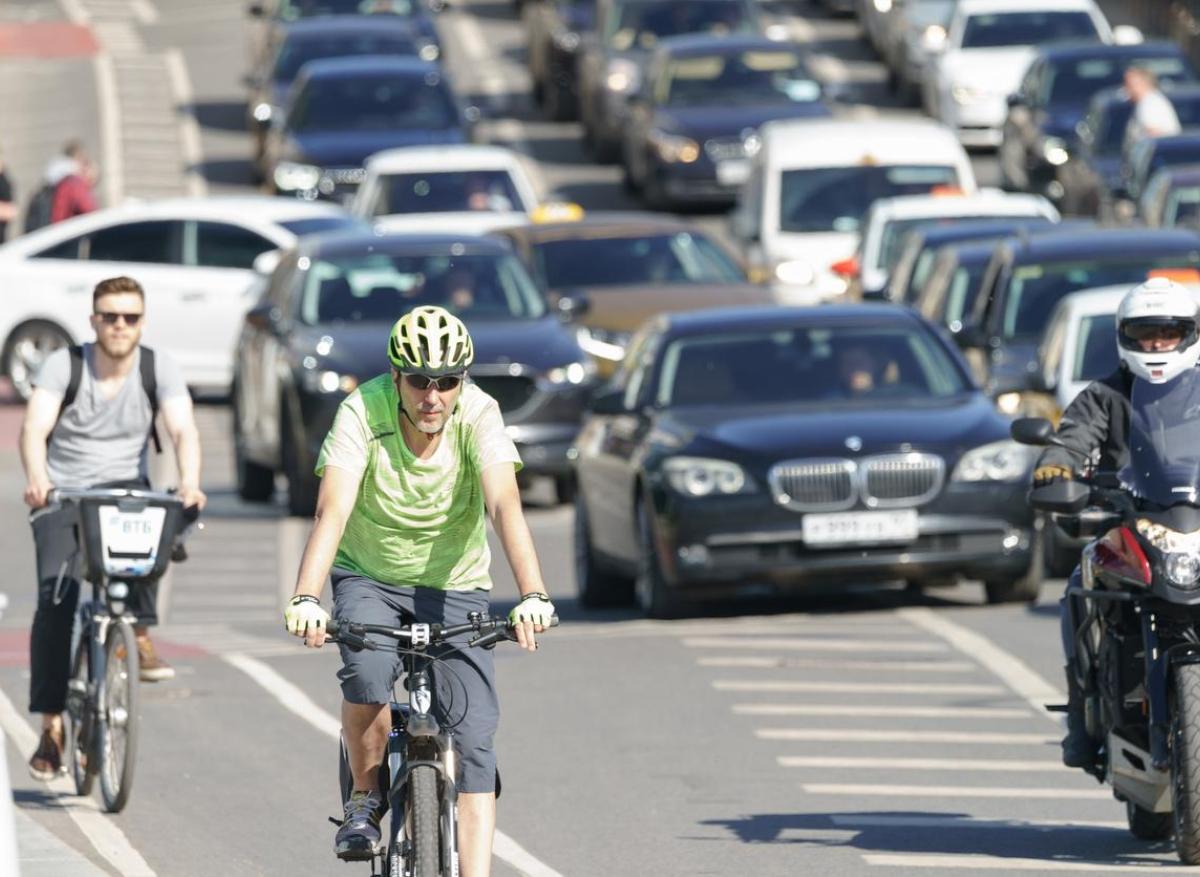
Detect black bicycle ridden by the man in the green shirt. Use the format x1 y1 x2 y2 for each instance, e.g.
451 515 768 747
325 612 558 877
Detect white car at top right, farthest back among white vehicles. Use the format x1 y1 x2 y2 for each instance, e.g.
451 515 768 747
924 0 1114 146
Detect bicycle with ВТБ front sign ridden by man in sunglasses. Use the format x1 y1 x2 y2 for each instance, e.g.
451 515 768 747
35 488 196 813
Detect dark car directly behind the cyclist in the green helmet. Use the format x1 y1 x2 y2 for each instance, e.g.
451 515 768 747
233 232 594 515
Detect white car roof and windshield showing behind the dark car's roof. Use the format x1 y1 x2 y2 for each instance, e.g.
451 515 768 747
350 144 549 234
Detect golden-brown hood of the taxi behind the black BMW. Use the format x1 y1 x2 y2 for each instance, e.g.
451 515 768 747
571 283 775 332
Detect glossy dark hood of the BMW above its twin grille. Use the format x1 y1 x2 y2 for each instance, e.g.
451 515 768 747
660 392 1008 467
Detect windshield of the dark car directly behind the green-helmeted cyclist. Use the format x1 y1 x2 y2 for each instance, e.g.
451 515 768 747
300 253 546 325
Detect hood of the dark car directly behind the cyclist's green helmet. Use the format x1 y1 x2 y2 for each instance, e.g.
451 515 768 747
292 317 587 380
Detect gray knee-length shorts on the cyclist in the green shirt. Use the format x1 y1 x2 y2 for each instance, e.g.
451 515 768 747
331 566 500 794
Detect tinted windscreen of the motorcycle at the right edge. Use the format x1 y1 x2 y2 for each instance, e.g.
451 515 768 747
1121 368 1200 507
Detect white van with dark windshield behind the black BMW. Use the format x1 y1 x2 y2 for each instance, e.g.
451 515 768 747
731 119 976 304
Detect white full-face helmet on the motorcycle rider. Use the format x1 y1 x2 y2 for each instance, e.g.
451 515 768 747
1117 277 1200 384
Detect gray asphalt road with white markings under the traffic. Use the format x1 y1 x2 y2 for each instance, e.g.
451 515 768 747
0 0 1190 877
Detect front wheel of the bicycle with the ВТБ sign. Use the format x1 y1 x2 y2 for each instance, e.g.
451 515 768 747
96 621 138 813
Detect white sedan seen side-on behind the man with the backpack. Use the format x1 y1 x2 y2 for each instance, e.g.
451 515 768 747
0 196 360 398
